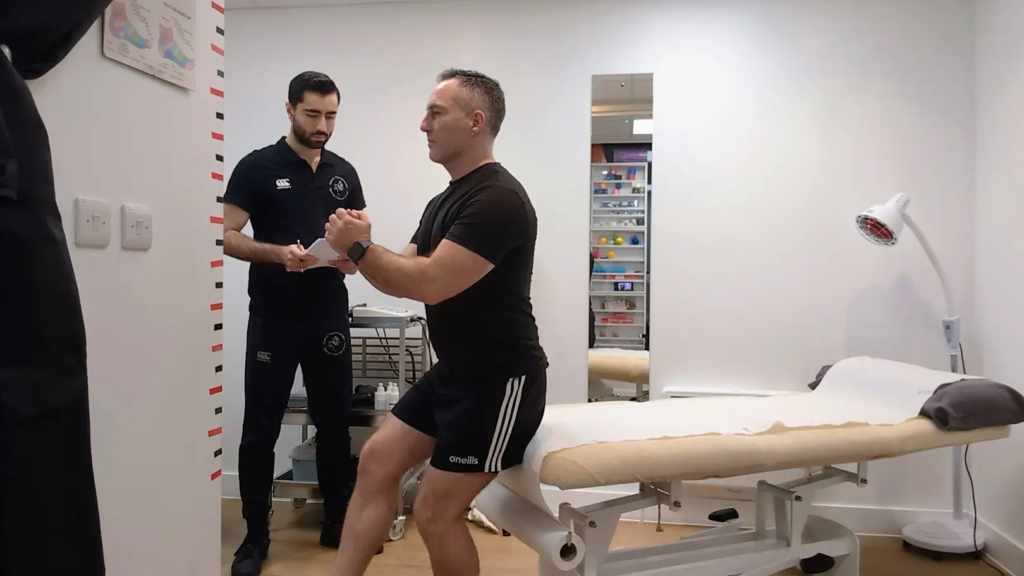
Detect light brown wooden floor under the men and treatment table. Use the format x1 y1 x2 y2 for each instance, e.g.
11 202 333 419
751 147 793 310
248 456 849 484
221 500 996 576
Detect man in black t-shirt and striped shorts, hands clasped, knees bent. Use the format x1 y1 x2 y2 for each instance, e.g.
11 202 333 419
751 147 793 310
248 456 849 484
326 70 548 576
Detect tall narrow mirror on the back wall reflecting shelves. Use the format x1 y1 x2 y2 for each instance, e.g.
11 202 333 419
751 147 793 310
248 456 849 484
587 74 654 401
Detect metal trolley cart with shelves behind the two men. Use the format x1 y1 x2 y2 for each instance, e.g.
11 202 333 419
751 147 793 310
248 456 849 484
272 308 432 540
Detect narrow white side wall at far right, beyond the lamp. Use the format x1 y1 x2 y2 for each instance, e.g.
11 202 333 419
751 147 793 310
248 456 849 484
968 0 1024 574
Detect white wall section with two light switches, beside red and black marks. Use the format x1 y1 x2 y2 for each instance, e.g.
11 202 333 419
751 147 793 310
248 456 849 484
29 4 222 576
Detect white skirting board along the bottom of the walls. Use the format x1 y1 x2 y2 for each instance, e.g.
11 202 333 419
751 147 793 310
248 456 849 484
220 472 1024 576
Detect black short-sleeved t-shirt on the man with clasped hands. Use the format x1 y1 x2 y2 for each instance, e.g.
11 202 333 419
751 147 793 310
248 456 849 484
412 162 548 377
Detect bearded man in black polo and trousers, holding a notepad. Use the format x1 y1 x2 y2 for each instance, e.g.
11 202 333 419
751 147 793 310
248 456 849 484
224 72 366 576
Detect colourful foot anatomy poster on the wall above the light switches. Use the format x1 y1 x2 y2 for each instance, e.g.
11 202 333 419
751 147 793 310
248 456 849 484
103 0 197 90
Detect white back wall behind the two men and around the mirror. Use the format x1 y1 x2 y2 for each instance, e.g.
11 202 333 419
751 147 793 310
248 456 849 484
225 0 977 520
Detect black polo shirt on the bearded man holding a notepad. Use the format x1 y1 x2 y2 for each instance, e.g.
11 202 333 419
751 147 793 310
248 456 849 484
224 138 367 314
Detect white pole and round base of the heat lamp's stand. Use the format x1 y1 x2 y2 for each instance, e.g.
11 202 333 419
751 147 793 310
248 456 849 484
903 317 985 554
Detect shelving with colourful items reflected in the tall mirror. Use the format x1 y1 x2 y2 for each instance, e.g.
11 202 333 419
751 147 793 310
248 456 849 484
590 162 650 349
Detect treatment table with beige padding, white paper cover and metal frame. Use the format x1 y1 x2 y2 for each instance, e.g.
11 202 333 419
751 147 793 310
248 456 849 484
476 357 1024 576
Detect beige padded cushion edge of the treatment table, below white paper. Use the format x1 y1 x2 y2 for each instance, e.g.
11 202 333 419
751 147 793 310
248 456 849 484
541 417 1010 490
